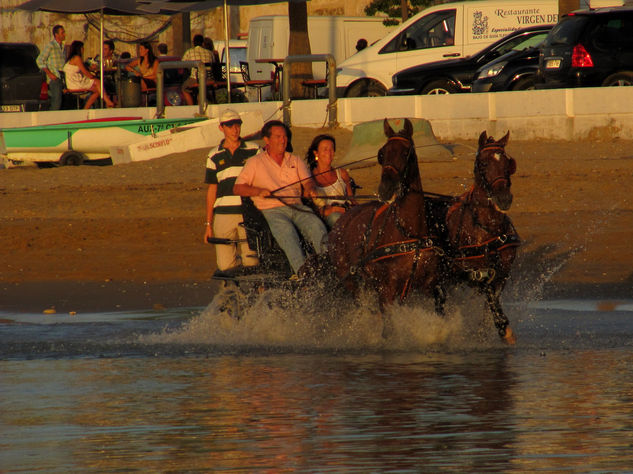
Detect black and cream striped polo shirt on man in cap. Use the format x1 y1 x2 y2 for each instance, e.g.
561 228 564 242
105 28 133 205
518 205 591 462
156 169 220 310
204 140 259 214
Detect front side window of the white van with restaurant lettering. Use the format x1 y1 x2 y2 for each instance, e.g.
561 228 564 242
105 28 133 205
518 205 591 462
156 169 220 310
380 10 457 54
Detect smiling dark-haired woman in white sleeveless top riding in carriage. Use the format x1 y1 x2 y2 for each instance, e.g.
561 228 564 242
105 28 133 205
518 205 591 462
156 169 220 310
306 134 354 229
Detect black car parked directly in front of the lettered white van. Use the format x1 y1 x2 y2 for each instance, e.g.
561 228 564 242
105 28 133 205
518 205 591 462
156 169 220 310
388 25 552 95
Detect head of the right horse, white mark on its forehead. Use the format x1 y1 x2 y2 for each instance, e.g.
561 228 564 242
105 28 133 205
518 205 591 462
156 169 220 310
475 131 517 211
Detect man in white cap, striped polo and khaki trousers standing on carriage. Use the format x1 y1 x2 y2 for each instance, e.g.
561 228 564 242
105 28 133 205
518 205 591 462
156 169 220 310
204 109 259 272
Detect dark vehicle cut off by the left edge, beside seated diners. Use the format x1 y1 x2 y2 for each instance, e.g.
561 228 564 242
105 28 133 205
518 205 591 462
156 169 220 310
0 43 48 112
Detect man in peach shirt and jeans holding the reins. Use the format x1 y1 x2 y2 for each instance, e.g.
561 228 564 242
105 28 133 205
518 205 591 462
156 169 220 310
233 120 327 279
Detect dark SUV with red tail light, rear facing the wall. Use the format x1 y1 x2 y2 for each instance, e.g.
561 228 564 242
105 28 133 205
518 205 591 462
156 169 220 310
536 7 633 89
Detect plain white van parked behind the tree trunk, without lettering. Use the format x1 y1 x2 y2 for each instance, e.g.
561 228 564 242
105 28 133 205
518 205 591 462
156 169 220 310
246 15 394 80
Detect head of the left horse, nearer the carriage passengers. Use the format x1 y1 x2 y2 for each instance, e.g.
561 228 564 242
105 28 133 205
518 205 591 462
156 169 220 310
378 119 422 201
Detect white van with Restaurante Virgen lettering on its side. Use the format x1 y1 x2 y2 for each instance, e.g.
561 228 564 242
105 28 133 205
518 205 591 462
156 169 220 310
336 0 558 97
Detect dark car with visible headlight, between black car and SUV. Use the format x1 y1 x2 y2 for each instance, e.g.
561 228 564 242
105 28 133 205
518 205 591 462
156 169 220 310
471 26 546 92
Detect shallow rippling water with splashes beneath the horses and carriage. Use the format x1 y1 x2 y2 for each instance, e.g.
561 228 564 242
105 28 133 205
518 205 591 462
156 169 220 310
0 295 633 472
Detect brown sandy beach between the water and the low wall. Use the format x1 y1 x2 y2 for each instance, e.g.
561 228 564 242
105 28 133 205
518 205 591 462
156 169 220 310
0 128 633 312
